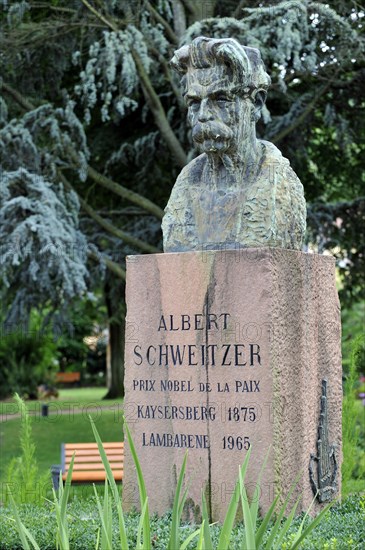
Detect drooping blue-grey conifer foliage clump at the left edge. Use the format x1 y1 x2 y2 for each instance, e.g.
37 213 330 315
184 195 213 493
0 168 88 323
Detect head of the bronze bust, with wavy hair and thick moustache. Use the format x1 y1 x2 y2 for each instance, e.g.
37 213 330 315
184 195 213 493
171 36 271 154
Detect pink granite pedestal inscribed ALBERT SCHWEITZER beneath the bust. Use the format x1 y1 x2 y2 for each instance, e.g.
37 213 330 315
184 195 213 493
123 248 342 521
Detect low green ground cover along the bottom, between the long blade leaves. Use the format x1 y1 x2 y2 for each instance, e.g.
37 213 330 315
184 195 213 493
0 496 365 550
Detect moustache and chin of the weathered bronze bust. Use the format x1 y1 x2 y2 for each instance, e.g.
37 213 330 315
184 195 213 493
192 120 234 154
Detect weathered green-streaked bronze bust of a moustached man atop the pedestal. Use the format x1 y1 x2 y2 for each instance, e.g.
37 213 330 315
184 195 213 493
162 37 306 252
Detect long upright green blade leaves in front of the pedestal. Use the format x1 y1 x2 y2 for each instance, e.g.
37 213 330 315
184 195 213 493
12 419 332 550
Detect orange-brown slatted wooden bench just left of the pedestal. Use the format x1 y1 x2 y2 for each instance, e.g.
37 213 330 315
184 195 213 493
51 442 124 489
